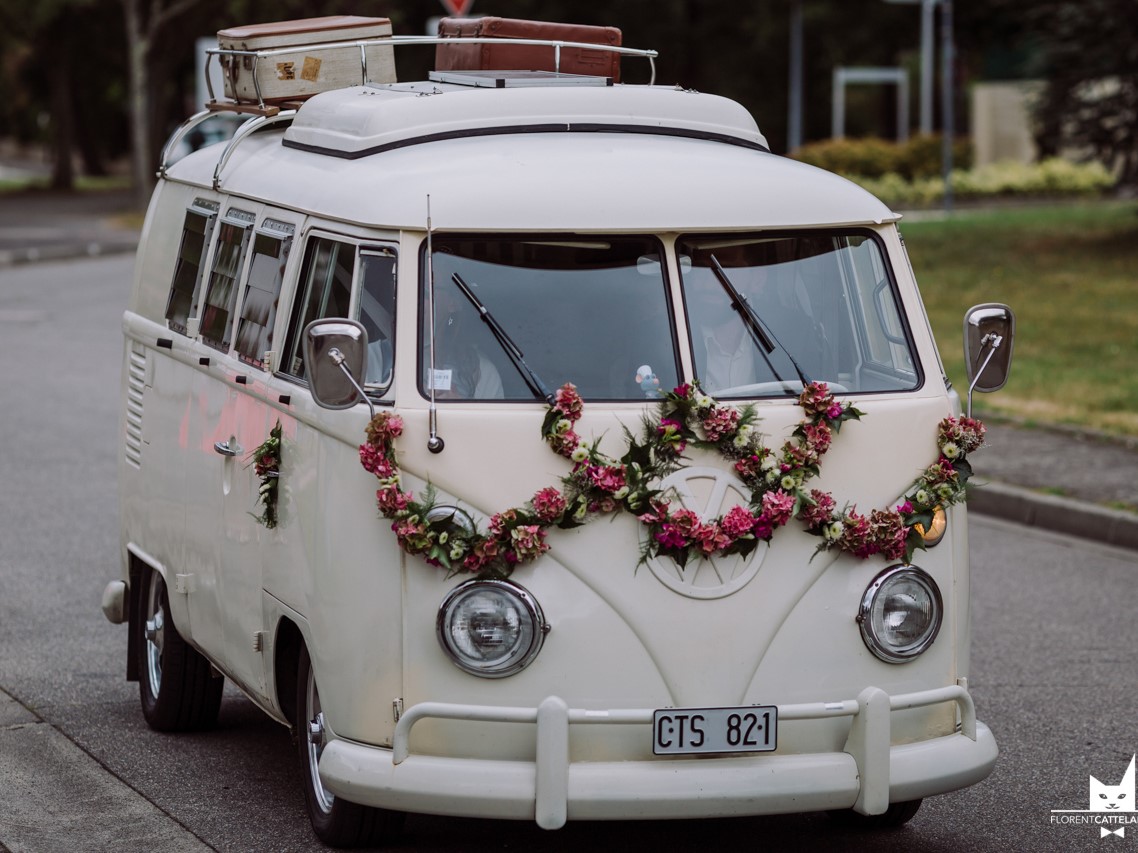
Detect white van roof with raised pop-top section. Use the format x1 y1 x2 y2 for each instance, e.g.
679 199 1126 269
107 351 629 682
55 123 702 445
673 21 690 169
165 81 897 232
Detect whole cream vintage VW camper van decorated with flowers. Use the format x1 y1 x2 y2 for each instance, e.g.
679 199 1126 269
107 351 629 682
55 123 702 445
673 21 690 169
104 18 1013 845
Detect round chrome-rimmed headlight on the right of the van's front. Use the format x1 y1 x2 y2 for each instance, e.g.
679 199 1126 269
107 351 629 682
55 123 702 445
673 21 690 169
857 565 942 663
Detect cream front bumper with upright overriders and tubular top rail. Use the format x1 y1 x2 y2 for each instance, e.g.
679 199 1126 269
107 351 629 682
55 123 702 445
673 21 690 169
320 685 998 829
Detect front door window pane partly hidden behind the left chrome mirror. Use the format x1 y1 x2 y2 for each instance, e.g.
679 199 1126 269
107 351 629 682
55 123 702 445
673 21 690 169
281 237 355 379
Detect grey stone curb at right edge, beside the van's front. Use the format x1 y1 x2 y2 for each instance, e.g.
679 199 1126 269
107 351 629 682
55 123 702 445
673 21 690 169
968 481 1138 550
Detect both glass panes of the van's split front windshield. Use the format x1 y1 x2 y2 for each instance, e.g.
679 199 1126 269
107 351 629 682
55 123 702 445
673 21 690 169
420 232 920 400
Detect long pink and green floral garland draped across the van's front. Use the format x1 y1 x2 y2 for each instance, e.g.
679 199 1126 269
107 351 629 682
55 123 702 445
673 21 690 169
360 382 984 578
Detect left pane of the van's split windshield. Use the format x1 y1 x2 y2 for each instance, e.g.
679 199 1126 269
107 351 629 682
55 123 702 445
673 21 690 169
420 235 679 400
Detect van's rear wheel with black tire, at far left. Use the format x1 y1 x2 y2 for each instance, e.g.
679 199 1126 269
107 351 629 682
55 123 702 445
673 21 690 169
134 571 225 731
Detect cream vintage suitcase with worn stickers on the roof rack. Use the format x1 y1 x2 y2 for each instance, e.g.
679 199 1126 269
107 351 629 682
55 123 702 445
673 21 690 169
217 15 395 103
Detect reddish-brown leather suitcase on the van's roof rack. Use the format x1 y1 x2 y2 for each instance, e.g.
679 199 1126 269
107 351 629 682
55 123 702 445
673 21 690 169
435 17 620 83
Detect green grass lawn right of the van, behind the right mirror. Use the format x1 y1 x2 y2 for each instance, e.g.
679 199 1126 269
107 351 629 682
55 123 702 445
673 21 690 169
901 202 1138 436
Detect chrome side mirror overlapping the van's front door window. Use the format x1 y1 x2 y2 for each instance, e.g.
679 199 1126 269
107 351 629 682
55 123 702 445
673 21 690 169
304 320 368 408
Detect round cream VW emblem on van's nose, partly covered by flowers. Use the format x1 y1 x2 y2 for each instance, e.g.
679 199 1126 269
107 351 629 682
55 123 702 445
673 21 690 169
648 467 769 598
